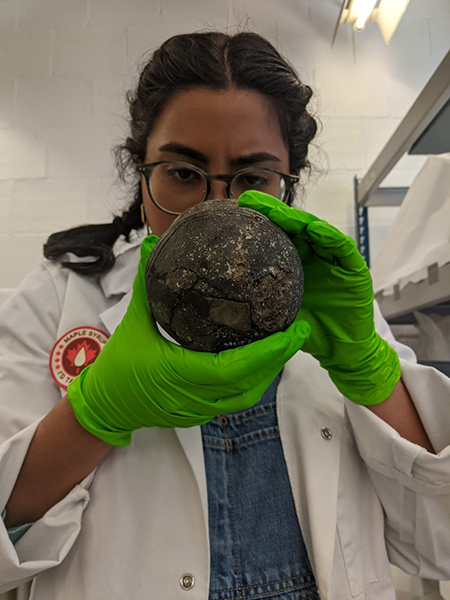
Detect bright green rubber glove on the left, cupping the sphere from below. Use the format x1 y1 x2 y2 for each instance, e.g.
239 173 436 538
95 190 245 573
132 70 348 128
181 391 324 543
67 236 311 446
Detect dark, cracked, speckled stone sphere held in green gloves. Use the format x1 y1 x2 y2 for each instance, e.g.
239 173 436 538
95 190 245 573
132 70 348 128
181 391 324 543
145 200 303 352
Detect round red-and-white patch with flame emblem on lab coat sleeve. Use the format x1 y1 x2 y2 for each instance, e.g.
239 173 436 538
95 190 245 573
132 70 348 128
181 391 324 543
50 327 109 390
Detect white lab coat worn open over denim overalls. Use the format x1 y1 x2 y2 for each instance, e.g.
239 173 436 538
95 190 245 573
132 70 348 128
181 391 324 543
0 231 450 600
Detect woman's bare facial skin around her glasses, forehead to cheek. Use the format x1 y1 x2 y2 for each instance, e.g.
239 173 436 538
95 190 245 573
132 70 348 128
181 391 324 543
141 87 289 236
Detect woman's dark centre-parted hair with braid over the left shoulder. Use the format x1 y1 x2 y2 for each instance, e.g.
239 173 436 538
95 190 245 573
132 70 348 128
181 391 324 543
44 31 317 275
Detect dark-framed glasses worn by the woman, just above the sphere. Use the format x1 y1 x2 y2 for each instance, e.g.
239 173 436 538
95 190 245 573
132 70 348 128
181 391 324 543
136 160 299 215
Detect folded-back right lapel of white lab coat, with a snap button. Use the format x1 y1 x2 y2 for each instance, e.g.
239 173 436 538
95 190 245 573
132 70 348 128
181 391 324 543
277 352 344 598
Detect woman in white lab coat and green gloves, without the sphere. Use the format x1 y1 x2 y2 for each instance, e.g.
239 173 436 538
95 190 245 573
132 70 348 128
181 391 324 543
0 33 450 600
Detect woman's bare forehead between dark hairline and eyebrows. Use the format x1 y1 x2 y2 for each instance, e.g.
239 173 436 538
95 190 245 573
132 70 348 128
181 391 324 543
147 88 287 159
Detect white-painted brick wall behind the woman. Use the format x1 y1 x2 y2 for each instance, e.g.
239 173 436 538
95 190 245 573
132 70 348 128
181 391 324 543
0 0 450 303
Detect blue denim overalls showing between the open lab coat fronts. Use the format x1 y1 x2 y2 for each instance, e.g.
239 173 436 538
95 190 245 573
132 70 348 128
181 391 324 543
201 373 319 600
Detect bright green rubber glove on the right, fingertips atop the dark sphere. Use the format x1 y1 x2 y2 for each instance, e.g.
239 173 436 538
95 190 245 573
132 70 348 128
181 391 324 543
238 191 401 405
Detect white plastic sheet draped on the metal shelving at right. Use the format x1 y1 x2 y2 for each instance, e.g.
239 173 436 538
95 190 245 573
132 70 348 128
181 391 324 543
371 153 450 296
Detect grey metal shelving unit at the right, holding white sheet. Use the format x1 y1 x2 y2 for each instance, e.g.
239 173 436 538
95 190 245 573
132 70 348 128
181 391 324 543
354 52 450 376
